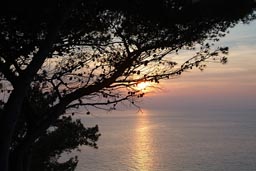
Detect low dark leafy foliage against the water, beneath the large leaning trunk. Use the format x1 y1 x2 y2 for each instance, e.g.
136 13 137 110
28 116 100 171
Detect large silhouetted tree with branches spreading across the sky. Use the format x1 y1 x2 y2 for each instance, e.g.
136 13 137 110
0 0 254 171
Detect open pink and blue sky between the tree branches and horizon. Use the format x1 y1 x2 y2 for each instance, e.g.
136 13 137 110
139 21 256 112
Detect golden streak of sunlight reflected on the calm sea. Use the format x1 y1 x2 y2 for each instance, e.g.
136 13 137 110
133 113 154 171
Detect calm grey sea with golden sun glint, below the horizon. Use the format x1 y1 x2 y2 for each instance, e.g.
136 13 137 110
70 110 256 171
